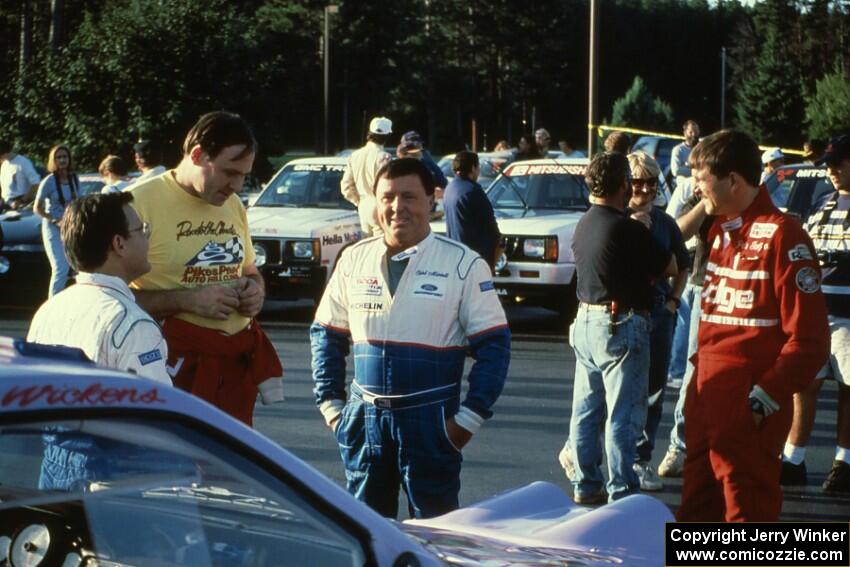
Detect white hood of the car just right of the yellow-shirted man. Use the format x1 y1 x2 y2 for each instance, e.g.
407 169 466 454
248 206 360 238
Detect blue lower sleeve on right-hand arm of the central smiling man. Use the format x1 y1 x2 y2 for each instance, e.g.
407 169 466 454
463 326 511 419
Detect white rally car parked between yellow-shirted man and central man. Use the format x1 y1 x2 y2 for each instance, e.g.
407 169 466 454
248 157 362 301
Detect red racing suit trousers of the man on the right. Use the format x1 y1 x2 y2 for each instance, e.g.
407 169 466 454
676 354 793 522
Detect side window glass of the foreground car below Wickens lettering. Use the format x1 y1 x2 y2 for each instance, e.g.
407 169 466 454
0 416 366 567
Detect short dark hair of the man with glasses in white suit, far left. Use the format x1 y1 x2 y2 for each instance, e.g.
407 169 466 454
62 191 133 272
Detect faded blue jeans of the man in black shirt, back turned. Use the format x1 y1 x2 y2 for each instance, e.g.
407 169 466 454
569 306 650 501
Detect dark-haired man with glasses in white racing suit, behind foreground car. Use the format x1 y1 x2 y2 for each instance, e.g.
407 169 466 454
27 192 173 490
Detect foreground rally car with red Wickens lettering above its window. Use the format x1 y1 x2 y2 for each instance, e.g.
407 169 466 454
0 339 673 567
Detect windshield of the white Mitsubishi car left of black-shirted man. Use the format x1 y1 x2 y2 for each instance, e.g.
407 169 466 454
487 162 590 211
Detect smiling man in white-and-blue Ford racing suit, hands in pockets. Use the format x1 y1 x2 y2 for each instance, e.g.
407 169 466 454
310 158 510 518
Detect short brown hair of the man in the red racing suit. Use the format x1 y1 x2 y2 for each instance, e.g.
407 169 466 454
688 128 761 187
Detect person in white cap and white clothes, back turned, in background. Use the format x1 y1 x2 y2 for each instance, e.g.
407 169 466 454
340 116 393 237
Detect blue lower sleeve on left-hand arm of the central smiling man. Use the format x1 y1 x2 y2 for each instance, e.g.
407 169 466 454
310 323 350 405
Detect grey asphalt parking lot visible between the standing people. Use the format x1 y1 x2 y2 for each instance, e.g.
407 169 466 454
0 302 850 521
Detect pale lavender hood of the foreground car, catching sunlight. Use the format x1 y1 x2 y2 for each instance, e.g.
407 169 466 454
401 482 673 567
